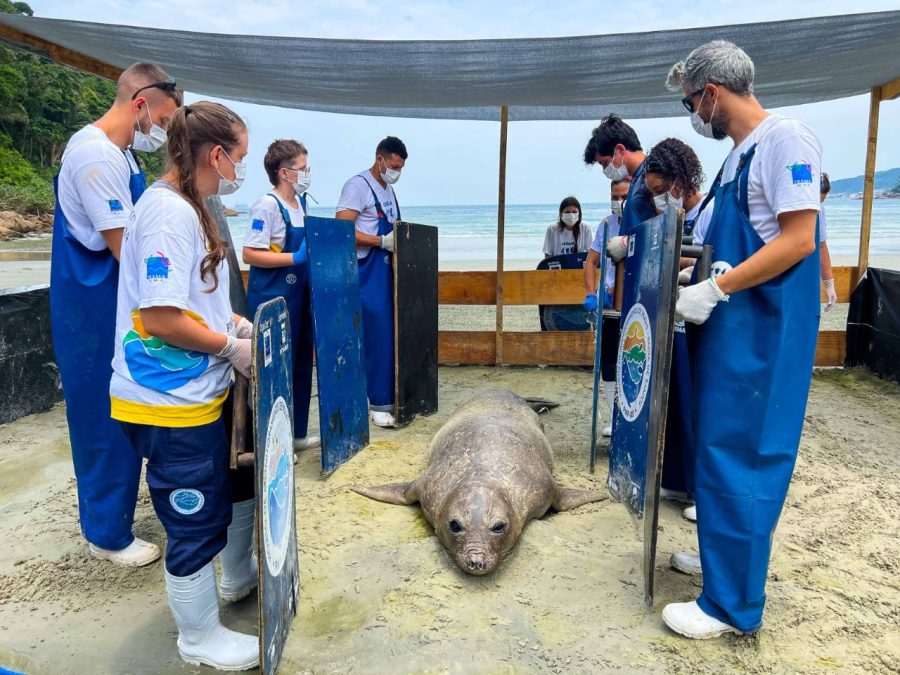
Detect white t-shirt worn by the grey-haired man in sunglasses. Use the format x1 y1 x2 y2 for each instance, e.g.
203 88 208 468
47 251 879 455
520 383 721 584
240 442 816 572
722 115 822 243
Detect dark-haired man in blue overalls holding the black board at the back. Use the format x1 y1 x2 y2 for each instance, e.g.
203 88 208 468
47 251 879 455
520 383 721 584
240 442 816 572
335 136 408 427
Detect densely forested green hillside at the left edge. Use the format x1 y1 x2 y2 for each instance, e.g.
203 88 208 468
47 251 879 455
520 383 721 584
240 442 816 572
0 0 164 213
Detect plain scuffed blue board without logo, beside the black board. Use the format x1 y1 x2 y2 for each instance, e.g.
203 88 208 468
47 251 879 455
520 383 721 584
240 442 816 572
305 216 369 473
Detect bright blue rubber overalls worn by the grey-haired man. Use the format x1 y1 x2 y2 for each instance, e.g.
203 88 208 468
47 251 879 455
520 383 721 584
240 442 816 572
693 145 820 632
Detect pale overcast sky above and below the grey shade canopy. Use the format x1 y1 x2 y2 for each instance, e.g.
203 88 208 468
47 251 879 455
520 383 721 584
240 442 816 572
29 0 900 205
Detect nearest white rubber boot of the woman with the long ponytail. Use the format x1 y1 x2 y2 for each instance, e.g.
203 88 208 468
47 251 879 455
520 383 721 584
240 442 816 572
166 563 259 670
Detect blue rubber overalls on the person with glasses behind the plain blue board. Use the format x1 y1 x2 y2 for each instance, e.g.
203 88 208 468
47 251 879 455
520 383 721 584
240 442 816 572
247 193 314 438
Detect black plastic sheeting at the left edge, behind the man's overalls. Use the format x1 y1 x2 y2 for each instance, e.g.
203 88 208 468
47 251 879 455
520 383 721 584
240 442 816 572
0 285 62 424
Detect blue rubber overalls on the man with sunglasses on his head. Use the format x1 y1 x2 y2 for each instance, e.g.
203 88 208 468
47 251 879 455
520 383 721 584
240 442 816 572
50 147 147 551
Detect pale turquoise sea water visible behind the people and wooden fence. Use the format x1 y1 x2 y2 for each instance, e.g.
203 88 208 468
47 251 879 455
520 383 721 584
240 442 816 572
228 199 900 269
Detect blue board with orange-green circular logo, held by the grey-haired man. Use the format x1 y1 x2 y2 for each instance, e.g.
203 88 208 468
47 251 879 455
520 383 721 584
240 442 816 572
607 207 681 607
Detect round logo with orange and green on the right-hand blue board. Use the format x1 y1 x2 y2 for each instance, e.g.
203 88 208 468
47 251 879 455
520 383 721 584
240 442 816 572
616 303 653 422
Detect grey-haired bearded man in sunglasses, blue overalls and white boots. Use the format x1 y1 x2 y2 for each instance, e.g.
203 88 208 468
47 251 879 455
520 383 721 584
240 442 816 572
662 40 821 638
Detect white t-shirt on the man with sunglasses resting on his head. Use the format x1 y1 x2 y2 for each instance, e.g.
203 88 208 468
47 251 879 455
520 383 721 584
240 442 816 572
58 124 138 251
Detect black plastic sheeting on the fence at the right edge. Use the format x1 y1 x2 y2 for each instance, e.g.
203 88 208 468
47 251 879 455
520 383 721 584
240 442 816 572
847 267 900 382
